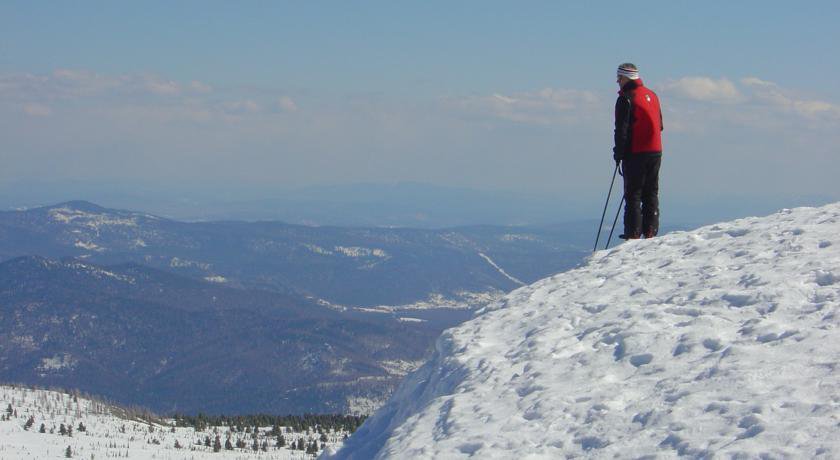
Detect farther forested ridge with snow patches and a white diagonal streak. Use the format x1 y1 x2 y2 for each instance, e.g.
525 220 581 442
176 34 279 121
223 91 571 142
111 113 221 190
0 201 593 306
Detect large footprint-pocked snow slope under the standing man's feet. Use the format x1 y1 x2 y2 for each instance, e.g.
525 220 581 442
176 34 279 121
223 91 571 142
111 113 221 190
324 203 840 459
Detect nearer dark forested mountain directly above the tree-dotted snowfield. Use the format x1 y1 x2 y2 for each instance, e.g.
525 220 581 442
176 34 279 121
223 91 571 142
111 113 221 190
0 256 440 413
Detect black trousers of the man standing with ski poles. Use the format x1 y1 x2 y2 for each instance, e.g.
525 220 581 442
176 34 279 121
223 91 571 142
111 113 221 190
622 153 662 238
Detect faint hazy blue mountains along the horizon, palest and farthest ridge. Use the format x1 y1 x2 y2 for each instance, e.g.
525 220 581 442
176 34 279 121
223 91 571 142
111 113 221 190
0 181 602 228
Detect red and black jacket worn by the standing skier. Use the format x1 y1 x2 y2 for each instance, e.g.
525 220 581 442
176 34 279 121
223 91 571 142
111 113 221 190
615 79 664 155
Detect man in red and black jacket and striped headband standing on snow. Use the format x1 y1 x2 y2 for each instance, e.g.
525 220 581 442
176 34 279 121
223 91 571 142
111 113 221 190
613 63 663 240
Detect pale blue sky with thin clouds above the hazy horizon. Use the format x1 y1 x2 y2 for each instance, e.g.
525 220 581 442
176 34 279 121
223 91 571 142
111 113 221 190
0 2 840 219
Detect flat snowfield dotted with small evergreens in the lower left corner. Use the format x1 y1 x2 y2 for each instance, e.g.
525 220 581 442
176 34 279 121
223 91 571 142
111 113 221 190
0 385 345 460
